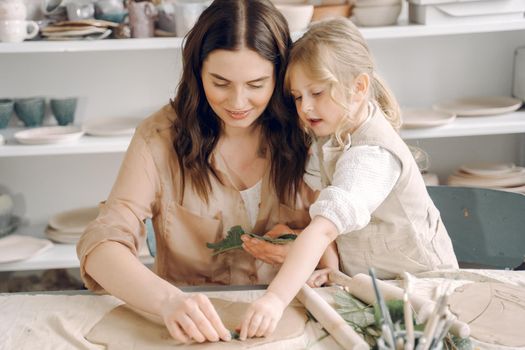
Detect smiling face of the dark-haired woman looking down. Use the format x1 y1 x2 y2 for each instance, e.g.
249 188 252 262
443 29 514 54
201 48 275 133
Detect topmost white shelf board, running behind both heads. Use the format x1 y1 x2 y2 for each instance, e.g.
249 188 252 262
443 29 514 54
0 20 525 54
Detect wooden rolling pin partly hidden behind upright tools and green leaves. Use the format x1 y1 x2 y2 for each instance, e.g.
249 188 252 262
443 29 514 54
328 270 470 338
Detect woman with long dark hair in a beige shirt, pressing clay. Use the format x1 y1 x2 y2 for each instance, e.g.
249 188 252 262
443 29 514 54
77 0 314 342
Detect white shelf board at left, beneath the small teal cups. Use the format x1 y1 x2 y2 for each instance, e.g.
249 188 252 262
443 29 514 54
0 128 131 158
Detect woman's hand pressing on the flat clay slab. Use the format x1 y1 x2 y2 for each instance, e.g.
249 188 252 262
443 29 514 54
161 293 231 343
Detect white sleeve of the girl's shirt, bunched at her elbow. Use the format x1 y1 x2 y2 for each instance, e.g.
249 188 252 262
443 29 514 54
310 145 401 234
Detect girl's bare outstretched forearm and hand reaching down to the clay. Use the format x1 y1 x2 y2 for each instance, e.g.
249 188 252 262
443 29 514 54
240 216 338 340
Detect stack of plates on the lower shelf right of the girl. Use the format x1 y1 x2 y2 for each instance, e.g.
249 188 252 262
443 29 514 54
448 163 525 194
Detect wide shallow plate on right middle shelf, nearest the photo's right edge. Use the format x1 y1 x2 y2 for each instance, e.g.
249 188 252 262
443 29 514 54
433 96 522 117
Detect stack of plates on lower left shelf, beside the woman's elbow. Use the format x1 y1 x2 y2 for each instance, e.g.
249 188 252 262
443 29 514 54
46 207 98 244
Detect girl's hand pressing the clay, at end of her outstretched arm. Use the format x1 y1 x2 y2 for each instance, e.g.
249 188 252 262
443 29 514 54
240 291 286 340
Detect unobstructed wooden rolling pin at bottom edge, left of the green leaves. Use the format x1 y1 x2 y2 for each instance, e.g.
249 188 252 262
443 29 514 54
297 284 370 350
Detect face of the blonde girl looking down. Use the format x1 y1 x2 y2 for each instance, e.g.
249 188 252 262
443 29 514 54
290 64 345 137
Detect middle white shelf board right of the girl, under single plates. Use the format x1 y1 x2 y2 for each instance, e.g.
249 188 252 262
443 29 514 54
401 111 525 140
